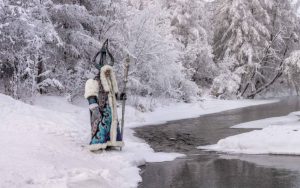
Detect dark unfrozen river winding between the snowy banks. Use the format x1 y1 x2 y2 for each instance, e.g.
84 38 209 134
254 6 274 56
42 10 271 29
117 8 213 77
135 97 300 188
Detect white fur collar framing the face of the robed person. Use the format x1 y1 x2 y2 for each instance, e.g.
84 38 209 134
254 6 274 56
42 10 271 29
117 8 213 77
100 65 119 93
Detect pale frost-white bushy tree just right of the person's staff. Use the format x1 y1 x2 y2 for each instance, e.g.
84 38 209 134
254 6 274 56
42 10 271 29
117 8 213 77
124 1 198 101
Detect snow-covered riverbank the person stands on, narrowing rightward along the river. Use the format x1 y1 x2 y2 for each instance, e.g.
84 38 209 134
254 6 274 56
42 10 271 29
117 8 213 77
0 94 274 188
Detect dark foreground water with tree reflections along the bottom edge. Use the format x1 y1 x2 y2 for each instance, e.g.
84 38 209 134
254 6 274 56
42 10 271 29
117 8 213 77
140 155 300 188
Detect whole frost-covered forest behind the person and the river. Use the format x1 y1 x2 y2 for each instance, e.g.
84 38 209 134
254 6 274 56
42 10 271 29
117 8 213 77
0 0 300 110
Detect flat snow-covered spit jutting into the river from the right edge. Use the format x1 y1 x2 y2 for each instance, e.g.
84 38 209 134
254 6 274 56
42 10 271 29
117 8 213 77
199 112 300 155
